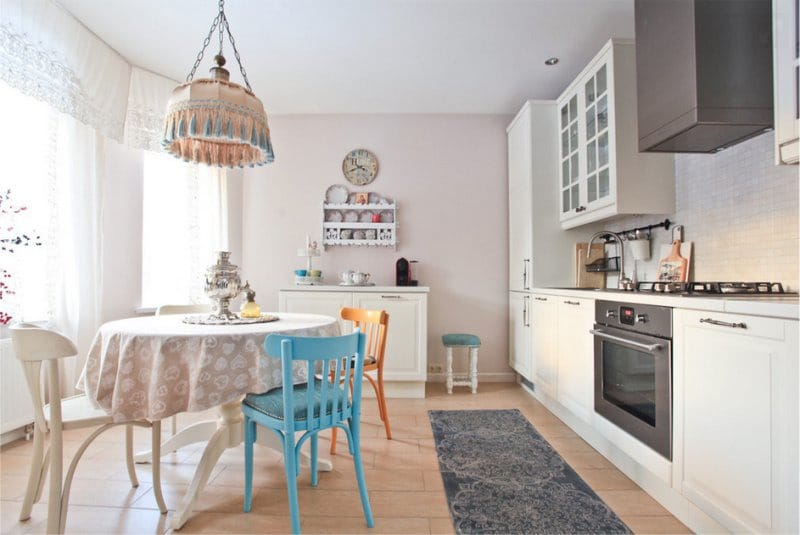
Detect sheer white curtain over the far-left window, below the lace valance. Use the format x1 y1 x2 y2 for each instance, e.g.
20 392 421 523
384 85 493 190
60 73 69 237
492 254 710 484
0 81 104 392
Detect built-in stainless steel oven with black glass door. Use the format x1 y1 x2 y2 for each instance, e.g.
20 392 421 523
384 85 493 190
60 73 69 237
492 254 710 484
591 300 672 460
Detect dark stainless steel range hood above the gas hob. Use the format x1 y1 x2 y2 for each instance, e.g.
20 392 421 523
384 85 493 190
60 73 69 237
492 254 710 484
635 0 773 152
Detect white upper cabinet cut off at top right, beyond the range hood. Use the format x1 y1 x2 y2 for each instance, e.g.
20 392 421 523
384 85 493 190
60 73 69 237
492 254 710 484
772 0 800 164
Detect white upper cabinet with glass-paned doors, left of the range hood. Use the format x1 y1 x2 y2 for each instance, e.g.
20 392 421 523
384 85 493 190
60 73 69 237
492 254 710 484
558 39 675 228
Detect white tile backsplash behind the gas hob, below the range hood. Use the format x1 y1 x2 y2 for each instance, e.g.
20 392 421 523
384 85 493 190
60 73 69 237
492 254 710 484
608 132 800 291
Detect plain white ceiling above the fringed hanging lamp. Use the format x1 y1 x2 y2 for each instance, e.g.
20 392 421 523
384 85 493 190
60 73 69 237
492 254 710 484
59 0 634 114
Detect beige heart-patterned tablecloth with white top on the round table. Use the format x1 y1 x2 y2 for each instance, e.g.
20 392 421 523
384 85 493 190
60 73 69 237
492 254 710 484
77 313 339 422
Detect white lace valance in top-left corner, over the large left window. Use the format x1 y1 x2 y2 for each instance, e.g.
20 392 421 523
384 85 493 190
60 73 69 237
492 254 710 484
0 0 131 141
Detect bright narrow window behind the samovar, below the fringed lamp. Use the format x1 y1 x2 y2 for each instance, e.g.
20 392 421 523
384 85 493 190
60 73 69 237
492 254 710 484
142 151 227 307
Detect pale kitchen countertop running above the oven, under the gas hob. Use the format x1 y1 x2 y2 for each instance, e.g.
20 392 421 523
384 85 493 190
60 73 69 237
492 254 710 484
531 288 800 320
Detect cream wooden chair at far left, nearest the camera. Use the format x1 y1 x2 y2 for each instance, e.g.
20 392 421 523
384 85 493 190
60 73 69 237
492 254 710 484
11 323 167 533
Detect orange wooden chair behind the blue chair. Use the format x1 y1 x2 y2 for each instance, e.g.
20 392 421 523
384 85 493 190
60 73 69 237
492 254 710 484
331 307 392 455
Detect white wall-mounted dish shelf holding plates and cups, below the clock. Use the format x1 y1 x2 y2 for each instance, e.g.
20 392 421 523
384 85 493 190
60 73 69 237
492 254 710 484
322 202 397 248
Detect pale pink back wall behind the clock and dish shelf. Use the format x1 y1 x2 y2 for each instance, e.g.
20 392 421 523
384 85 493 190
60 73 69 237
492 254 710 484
241 115 510 378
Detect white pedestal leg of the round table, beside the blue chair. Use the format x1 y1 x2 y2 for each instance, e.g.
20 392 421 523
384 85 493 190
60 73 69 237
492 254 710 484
170 401 333 529
